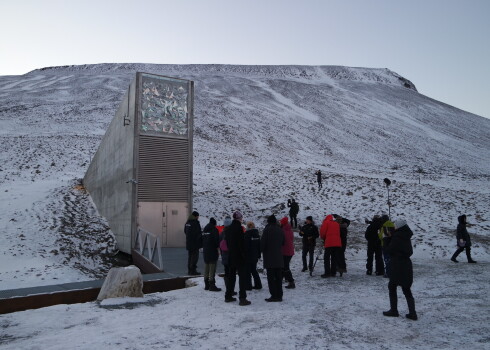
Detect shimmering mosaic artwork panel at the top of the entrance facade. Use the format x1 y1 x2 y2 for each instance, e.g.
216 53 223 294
141 75 189 136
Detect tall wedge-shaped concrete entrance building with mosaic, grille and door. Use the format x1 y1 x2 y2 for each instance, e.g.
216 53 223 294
83 73 194 260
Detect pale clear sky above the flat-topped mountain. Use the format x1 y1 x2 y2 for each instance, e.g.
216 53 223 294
0 0 490 118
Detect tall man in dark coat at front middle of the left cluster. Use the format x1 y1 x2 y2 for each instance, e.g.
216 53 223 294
225 211 251 306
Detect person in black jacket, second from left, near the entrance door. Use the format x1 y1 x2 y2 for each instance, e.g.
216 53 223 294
202 218 221 292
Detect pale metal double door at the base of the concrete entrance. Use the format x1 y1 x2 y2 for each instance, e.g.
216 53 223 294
138 202 188 247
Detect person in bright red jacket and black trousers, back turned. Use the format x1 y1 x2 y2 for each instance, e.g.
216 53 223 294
320 215 345 278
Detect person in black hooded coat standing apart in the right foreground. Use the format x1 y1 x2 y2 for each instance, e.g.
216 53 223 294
383 219 417 320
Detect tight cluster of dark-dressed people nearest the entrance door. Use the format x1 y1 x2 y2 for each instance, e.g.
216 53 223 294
184 210 296 306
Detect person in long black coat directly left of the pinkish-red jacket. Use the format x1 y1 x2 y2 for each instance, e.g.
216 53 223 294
260 215 284 302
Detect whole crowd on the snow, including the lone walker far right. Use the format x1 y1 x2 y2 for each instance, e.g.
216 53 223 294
185 206 476 320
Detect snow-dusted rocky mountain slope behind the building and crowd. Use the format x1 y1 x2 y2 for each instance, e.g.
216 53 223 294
0 64 490 289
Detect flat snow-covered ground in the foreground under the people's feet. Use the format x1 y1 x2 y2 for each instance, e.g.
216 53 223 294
0 254 490 350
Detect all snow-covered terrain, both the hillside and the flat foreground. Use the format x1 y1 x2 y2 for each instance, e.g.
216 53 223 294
0 64 490 349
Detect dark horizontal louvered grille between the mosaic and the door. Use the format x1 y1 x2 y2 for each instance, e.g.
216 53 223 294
138 135 190 202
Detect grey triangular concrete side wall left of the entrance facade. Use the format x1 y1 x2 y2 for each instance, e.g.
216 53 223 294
83 78 137 254
